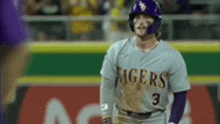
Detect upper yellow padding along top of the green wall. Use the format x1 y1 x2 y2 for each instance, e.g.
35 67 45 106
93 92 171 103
30 42 220 53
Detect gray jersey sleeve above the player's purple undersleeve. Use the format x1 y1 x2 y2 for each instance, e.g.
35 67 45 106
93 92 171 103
168 52 190 92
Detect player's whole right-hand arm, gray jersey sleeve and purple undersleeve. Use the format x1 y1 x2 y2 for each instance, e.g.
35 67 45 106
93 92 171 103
169 52 190 124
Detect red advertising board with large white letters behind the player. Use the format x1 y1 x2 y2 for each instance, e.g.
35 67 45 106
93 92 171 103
19 86 216 124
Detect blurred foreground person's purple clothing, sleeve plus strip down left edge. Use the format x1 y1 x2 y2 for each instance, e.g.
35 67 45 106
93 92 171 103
0 0 30 119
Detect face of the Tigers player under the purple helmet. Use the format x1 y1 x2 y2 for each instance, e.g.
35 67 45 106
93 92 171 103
134 14 154 37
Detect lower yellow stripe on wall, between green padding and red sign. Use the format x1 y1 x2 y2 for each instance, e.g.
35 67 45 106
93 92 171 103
18 75 220 86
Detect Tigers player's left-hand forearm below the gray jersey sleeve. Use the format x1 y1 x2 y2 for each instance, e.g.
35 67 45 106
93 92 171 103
100 77 115 124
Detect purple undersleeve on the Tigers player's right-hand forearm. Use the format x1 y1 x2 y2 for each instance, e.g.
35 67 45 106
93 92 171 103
169 91 187 124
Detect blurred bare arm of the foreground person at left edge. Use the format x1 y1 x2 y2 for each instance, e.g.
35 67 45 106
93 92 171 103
1 44 30 107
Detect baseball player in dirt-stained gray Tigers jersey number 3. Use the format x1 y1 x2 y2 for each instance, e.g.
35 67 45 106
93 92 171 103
100 0 190 124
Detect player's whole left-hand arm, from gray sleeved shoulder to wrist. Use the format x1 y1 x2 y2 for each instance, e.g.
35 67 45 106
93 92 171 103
100 43 119 124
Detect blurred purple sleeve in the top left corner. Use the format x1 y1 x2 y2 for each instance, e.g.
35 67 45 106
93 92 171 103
0 0 30 46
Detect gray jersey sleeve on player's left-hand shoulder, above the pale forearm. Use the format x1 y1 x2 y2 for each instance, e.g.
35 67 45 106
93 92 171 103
100 43 119 80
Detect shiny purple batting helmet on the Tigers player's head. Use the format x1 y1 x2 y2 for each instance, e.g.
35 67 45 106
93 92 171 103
129 0 162 34
